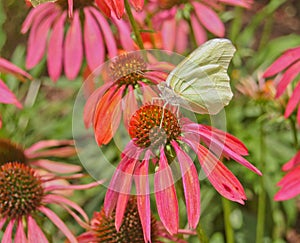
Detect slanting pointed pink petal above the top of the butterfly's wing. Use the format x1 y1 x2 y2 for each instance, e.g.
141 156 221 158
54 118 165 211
192 1 225 37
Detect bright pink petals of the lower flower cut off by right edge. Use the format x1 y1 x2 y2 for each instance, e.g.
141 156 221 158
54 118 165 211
274 151 300 201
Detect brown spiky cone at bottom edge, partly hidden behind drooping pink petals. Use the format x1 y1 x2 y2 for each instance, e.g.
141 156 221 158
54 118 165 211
92 197 158 243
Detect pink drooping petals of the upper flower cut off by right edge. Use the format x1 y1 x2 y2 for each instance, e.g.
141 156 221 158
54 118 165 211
264 47 300 124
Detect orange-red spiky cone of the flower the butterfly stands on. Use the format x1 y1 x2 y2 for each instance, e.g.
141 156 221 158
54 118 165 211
129 105 181 149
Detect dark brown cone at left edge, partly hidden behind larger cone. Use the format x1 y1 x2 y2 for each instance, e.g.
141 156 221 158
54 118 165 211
0 139 27 166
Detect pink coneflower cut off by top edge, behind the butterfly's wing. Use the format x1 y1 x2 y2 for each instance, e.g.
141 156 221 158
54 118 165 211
149 0 253 53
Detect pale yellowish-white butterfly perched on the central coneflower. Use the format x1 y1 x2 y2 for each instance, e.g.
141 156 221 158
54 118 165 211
158 39 235 114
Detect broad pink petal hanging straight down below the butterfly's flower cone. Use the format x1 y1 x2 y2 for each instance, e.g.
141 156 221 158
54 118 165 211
154 148 179 234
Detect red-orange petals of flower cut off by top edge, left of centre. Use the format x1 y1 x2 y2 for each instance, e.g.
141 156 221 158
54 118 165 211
96 0 144 19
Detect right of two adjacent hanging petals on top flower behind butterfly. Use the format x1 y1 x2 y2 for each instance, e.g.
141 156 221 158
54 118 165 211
175 20 189 53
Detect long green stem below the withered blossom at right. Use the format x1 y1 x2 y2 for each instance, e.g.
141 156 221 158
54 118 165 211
256 118 266 243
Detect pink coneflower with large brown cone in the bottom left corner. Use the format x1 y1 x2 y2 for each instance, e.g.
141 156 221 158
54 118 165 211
0 162 103 243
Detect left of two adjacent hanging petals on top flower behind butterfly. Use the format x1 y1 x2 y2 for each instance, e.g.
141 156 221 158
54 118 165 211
161 18 177 51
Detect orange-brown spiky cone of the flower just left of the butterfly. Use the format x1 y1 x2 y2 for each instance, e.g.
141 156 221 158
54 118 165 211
109 53 147 86
